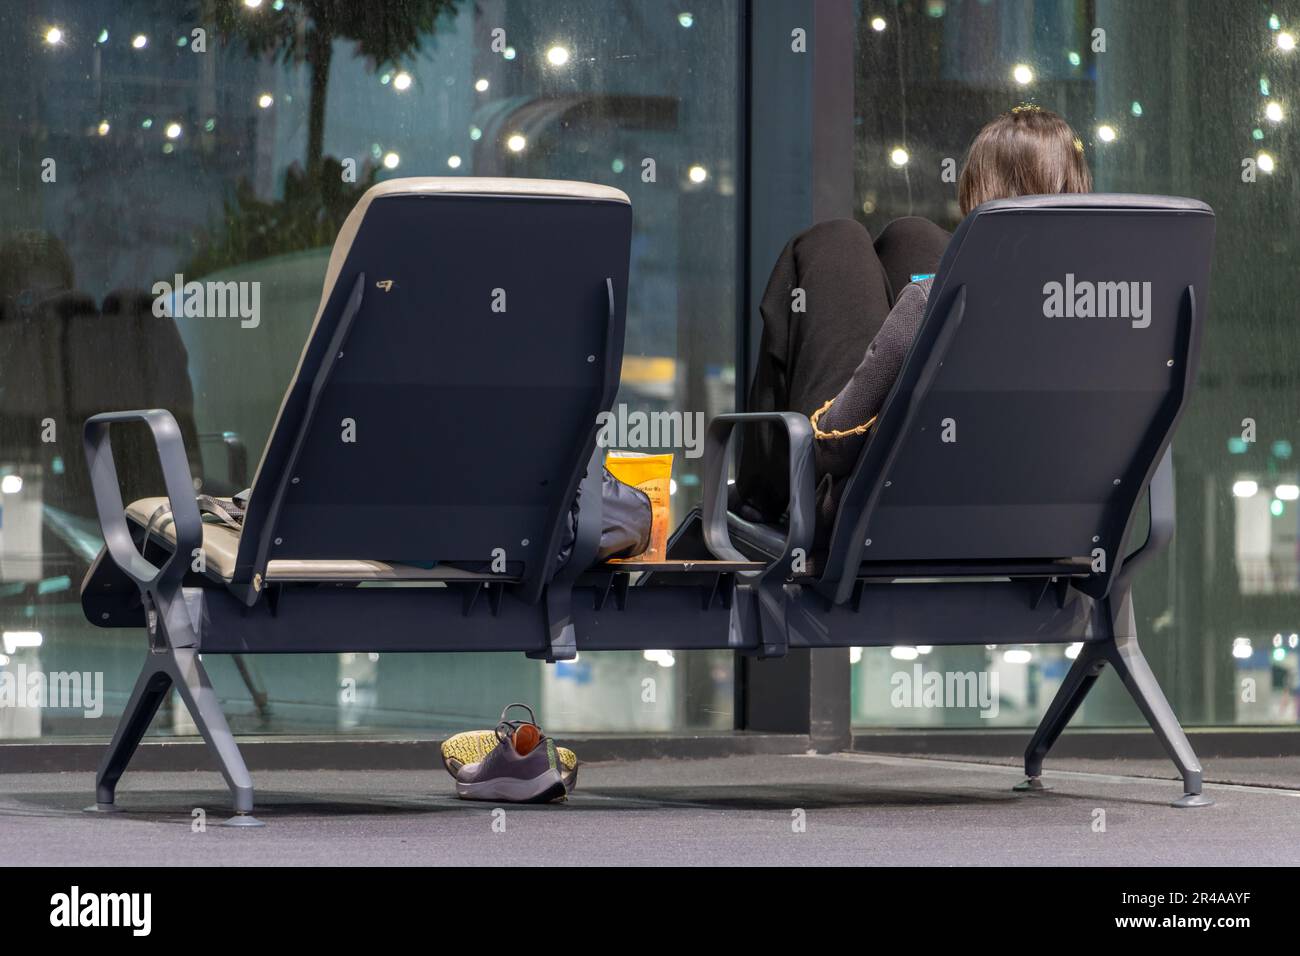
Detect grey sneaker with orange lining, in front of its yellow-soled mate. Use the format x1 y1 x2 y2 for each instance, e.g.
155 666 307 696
455 704 568 804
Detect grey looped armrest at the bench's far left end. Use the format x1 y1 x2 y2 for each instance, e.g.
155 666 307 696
83 408 203 589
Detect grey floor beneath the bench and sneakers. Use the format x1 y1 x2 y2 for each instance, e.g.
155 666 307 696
0 754 1300 866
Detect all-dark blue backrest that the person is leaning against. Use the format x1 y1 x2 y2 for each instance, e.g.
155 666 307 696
822 194 1214 600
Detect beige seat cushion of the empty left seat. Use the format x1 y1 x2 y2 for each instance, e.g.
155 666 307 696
126 497 464 581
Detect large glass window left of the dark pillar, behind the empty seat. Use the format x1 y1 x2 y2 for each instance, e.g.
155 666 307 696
0 0 741 737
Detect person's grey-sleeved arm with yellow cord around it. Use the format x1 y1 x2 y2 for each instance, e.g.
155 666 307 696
810 278 933 477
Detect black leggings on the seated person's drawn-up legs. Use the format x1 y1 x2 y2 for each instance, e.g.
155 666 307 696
732 216 950 522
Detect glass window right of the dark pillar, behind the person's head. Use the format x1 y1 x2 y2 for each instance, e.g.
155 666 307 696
853 0 1300 726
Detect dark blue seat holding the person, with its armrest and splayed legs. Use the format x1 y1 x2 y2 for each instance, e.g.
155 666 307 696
703 194 1214 805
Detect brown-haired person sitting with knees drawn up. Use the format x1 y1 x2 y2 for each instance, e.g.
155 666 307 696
732 105 1092 548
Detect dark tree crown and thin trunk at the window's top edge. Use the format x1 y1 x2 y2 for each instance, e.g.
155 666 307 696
207 0 460 174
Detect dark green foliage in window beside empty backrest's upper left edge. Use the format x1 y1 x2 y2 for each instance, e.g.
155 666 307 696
181 156 378 276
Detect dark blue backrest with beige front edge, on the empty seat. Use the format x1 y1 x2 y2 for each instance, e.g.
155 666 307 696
240 178 632 598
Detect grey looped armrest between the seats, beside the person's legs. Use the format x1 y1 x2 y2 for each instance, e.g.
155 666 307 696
703 411 816 574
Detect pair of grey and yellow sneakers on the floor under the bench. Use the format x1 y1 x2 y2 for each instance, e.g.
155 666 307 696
442 704 577 803
